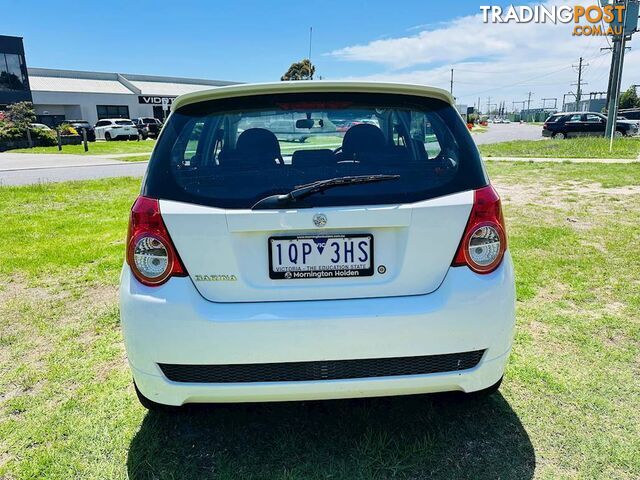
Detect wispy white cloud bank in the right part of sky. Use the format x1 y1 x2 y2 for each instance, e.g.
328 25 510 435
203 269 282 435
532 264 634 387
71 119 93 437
328 0 640 107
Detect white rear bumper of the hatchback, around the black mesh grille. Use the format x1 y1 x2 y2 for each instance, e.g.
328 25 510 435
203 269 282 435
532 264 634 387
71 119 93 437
120 253 515 405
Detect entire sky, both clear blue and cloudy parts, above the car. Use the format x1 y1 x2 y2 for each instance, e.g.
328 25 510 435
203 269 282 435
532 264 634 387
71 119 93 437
0 0 640 106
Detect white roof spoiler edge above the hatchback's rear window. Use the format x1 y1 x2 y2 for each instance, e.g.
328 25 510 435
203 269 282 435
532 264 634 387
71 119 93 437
171 80 454 111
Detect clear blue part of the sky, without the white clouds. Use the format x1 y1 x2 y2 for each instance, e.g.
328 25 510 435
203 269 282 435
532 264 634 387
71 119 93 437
0 0 510 81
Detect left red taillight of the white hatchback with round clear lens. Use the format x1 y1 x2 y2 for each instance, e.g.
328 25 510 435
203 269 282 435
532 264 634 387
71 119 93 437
127 196 187 286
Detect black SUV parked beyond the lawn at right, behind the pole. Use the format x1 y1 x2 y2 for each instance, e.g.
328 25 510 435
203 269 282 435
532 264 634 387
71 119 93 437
542 112 638 138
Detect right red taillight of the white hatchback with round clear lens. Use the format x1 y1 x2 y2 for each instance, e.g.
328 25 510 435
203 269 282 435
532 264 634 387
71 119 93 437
452 185 507 273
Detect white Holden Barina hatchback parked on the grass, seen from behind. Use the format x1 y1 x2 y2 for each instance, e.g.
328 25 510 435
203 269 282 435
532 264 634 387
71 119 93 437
120 82 515 408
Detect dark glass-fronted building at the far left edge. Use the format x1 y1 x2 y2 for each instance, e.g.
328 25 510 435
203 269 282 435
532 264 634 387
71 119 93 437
0 35 31 110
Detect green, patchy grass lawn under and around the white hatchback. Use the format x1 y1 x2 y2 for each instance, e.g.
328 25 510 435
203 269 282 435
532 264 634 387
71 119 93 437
0 162 640 480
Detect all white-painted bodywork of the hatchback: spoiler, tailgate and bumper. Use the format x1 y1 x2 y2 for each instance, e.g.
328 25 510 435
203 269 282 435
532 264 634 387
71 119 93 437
120 82 515 405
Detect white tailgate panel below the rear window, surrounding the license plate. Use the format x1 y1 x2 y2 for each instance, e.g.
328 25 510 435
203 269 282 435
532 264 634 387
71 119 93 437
160 191 473 302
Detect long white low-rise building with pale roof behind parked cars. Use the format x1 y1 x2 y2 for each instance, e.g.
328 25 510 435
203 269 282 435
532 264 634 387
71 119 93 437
28 68 237 126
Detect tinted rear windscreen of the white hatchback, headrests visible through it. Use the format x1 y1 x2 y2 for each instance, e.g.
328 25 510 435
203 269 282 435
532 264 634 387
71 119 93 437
143 93 487 208
